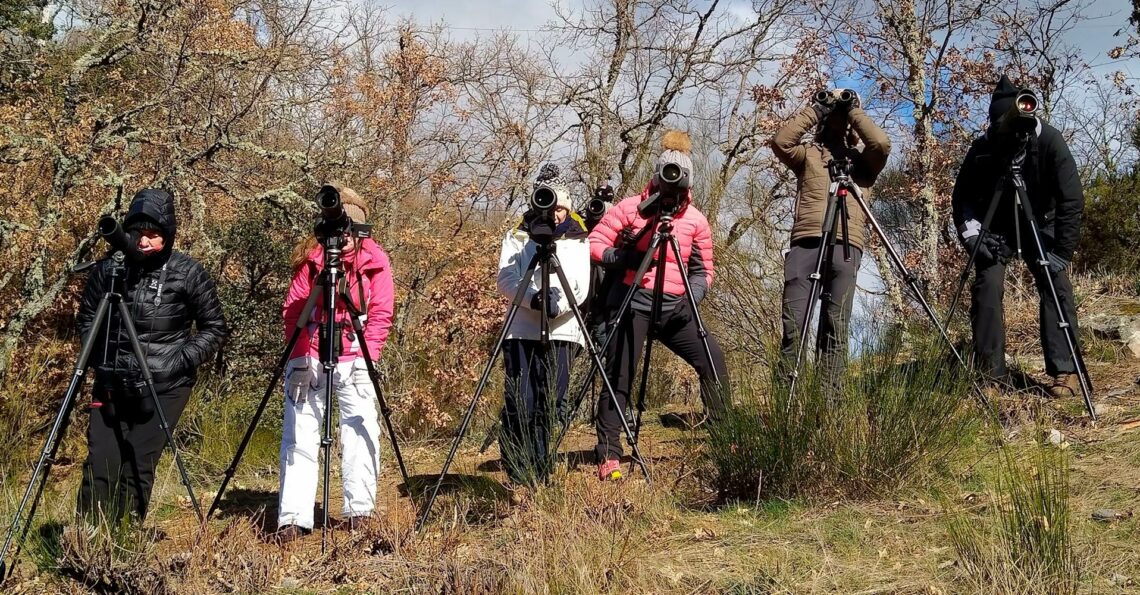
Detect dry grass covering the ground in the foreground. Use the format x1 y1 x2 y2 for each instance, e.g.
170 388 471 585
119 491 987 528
0 328 1140 594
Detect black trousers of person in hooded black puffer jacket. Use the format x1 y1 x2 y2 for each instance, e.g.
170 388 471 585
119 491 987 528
79 386 192 523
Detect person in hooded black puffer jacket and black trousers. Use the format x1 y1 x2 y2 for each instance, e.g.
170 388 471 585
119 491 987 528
79 189 227 522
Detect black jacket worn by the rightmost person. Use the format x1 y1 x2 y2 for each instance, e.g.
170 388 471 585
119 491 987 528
952 122 1084 260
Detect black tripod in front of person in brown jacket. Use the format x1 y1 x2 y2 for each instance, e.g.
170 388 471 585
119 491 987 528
788 157 992 413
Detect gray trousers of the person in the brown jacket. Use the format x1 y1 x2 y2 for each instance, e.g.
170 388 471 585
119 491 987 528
780 238 863 386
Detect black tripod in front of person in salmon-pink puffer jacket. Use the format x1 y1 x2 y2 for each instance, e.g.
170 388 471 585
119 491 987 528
555 208 723 462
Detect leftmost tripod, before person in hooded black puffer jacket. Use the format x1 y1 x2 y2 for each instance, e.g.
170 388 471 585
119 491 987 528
0 251 205 579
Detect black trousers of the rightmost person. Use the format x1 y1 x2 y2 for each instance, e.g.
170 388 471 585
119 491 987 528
970 243 1078 377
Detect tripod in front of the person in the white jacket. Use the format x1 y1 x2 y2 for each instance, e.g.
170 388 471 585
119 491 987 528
416 234 649 531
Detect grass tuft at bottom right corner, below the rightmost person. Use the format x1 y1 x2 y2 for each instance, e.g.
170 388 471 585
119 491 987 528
948 435 1080 595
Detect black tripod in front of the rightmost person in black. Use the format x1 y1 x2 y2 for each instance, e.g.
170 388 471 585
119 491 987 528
946 132 1097 422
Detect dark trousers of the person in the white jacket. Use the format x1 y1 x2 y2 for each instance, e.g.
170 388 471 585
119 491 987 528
499 339 578 484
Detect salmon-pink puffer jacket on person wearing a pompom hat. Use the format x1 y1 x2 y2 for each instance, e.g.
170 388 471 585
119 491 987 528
589 187 713 302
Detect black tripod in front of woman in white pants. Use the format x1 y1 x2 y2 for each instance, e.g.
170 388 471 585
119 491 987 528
206 228 408 552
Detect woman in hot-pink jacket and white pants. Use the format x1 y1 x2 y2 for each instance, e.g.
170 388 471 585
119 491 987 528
277 187 394 541
